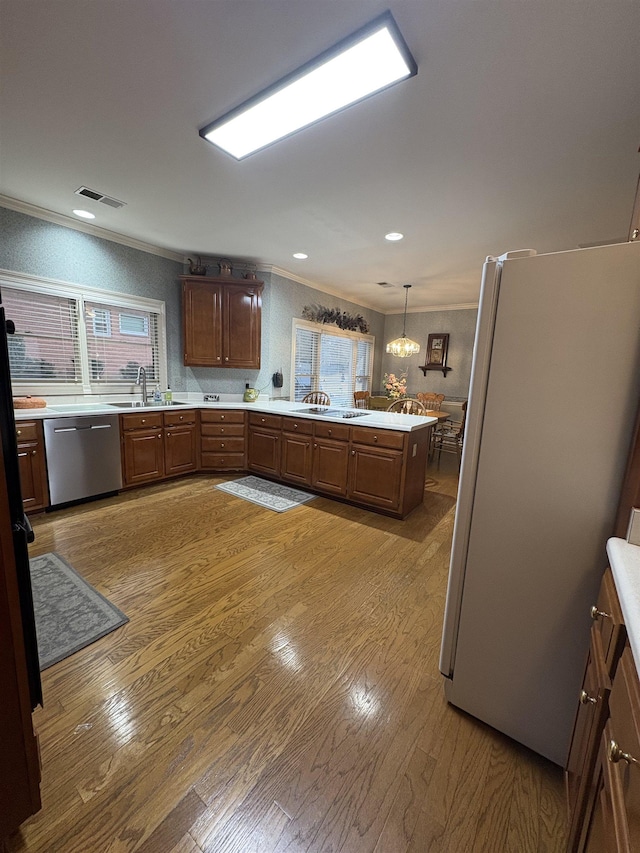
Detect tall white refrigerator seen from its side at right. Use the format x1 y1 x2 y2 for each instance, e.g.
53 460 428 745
440 242 640 766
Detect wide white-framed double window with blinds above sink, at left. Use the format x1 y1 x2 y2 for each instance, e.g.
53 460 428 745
0 279 167 394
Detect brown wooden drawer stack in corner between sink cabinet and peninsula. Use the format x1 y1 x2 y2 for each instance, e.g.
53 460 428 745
200 409 247 471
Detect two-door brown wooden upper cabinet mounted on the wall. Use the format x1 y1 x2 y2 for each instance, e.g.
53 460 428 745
181 276 263 369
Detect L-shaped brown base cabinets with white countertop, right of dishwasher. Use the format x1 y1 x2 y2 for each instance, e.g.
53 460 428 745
15 395 436 518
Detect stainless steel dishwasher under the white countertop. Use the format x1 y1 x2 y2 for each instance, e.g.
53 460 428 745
44 415 122 505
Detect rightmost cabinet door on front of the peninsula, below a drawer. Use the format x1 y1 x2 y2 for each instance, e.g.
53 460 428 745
347 444 403 510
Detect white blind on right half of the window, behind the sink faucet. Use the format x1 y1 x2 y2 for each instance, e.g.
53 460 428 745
84 302 160 384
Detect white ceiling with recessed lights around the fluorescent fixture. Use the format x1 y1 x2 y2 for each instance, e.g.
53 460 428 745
0 0 640 312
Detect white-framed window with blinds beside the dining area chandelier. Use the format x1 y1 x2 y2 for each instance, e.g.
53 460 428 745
292 320 374 406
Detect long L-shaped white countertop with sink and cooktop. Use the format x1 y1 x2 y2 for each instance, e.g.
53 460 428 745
14 400 437 432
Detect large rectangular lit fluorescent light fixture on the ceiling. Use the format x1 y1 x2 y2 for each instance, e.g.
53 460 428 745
200 12 418 160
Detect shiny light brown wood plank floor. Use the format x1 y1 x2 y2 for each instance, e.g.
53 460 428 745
3 464 565 853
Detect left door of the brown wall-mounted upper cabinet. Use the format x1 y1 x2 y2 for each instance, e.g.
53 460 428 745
182 279 223 367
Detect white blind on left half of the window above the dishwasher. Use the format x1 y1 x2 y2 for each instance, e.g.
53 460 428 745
2 287 82 383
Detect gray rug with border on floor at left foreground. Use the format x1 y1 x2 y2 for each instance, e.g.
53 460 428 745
29 553 129 670
